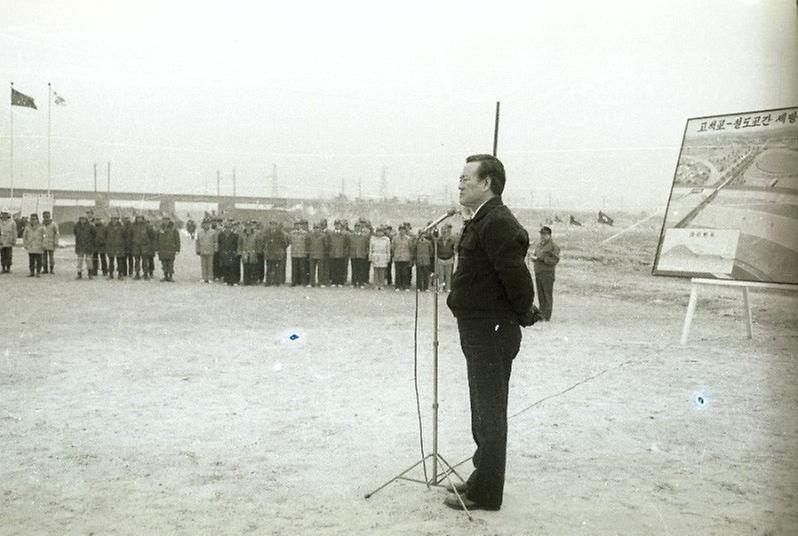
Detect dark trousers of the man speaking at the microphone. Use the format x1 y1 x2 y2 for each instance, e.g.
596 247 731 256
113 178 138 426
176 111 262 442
457 318 521 509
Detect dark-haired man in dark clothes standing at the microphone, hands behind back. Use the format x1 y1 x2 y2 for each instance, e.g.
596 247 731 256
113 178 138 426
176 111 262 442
444 154 536 510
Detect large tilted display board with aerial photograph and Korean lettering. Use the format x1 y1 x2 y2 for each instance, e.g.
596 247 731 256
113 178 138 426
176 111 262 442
653 107 798 284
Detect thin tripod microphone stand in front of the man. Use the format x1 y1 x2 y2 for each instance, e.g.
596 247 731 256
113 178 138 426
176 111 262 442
365 210 471 519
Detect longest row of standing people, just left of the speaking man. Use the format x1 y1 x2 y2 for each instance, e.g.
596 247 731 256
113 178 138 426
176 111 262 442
196 214 455 290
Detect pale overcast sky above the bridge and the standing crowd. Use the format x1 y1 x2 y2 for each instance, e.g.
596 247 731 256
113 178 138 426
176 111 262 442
0 0 798 208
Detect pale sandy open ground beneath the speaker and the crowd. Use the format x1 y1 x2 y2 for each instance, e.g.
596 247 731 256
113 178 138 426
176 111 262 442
0 230 798 536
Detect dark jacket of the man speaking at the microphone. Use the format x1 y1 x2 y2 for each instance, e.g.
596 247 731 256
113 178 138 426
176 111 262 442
446 196 535 321
